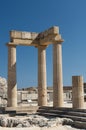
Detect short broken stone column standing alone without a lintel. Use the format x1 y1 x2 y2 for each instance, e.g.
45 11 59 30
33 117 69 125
72 76 84 109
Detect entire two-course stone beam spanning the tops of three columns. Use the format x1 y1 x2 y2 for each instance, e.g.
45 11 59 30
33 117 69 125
10 26 63 46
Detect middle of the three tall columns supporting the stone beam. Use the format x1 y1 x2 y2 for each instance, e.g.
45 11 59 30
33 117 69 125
38 46 47 106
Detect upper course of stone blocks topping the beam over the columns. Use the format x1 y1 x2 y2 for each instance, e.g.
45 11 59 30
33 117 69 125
10 26 59 40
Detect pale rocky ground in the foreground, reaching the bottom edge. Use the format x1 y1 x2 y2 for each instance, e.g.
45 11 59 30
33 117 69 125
0 114 84 130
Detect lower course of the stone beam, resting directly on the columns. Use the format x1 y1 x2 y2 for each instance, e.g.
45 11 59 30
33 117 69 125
7 35 63 46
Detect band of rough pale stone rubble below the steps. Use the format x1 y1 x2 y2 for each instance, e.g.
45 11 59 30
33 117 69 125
0 115 73 128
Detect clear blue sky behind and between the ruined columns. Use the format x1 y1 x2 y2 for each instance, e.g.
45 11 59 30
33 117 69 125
0 0 86 88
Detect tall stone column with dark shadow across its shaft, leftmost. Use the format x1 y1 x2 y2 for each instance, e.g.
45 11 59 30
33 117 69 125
7 45 17 107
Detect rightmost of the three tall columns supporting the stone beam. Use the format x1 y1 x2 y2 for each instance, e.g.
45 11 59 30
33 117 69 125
53 42 63 107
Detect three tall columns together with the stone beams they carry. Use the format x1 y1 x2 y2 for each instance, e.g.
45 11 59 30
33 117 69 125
7 26 63 107
